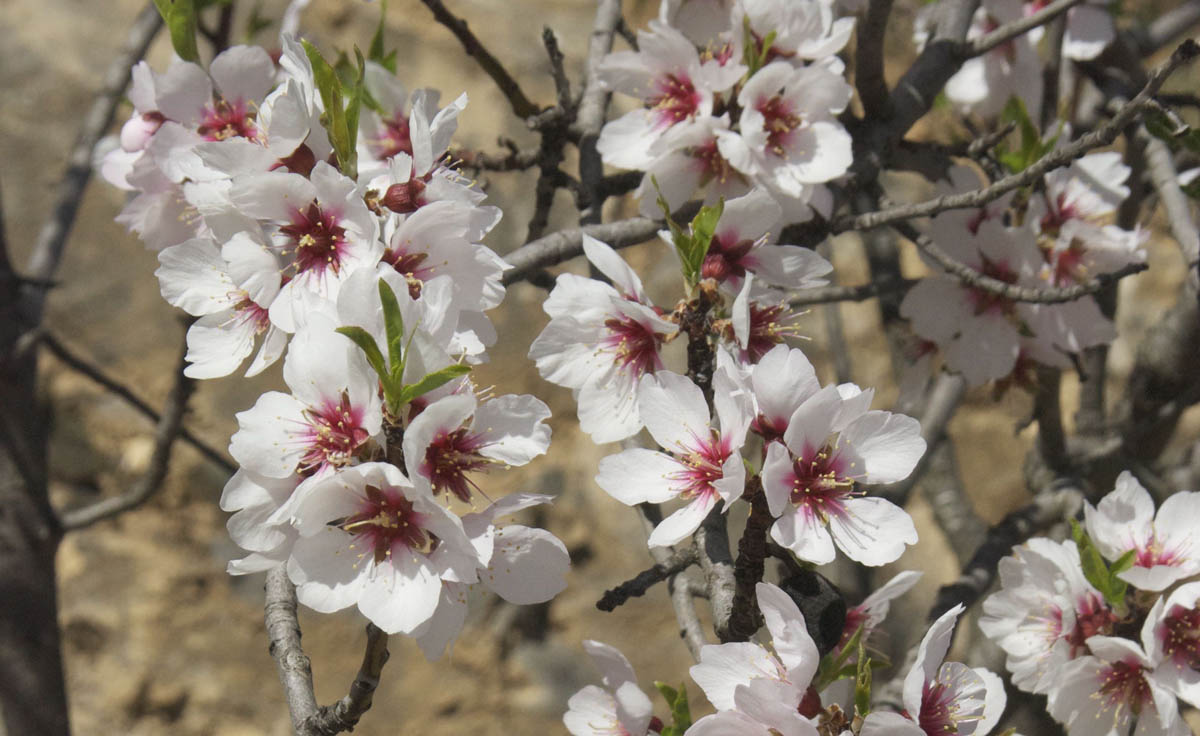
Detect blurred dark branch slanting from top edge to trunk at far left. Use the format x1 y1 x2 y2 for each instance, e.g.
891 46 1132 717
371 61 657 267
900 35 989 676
23 2 162 327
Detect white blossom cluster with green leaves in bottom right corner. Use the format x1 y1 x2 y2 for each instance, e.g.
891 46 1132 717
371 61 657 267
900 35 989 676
979 472 1200 736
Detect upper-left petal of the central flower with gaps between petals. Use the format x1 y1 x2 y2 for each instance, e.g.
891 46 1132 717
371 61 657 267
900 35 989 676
637 371 710 451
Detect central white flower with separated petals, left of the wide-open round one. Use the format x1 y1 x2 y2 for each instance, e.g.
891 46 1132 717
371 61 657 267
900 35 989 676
596 370 751 546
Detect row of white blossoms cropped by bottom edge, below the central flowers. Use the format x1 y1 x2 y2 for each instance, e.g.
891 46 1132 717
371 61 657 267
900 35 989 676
563 573 1006 736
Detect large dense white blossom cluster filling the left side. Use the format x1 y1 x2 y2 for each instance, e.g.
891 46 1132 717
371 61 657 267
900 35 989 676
101 35 569 658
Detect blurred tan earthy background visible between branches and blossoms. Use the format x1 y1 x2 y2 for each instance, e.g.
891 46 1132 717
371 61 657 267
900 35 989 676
7 0 1196 736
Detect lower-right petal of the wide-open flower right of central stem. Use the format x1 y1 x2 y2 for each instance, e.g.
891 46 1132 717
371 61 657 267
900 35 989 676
829 497 917 567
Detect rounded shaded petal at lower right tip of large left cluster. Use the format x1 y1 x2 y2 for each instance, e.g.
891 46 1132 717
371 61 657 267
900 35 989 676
480 523 571 605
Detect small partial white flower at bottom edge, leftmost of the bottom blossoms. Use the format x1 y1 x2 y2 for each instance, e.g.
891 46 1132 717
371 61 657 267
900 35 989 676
563 639 661 736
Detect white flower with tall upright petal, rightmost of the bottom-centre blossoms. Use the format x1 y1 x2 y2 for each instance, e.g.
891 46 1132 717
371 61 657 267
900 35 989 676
862 604 1006 736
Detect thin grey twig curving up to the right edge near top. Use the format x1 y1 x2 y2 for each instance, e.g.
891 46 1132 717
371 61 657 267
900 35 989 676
830 40 1200 233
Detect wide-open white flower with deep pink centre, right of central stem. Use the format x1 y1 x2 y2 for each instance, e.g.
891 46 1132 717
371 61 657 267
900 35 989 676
762 385 925 566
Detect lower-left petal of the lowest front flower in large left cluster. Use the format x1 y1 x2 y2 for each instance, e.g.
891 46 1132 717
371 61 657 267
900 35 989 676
288 528 365 614
